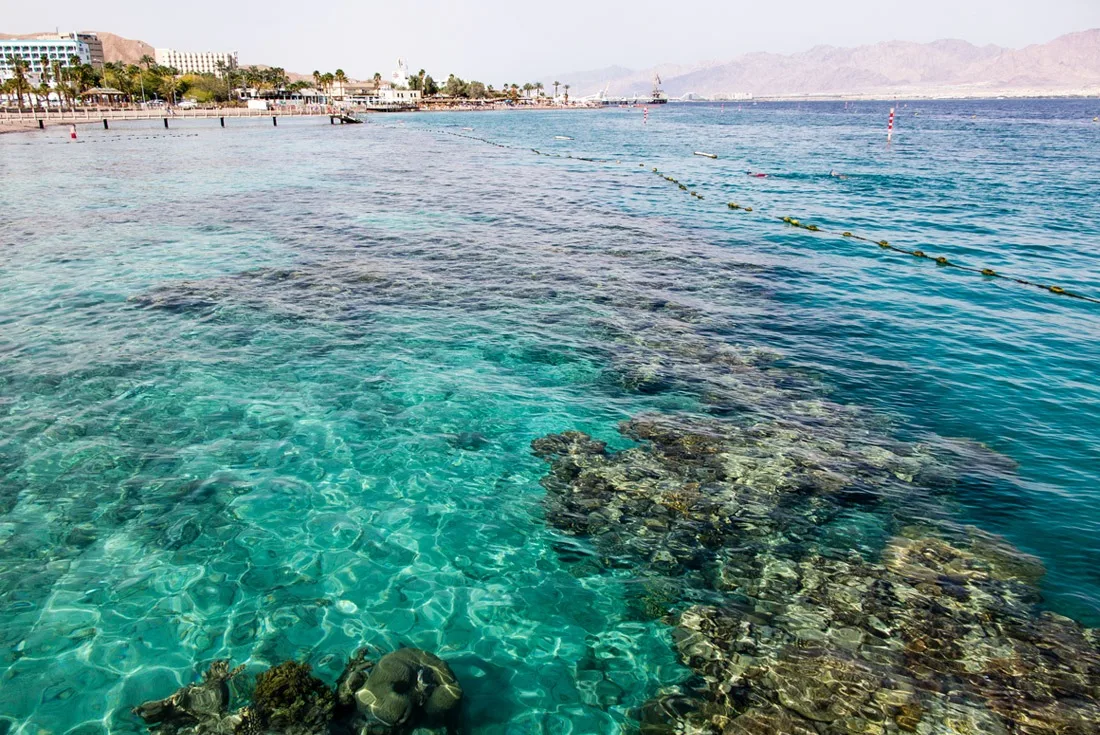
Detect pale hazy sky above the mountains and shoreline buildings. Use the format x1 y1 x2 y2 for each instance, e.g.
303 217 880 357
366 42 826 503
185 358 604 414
8 0 1100 85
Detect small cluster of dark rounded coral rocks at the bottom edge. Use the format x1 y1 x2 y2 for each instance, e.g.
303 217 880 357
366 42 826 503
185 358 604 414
133 648 462 735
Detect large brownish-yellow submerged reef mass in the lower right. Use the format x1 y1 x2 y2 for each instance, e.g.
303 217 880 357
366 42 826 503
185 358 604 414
532 417 1100 735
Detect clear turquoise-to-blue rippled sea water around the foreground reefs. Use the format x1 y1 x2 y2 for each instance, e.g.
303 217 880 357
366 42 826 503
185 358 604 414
0 100 1100 733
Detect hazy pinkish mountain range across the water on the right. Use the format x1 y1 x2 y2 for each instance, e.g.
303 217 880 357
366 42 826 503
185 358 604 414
542 29 1100 97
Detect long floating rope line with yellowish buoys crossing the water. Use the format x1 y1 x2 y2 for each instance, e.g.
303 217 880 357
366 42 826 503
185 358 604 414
400 120 1100 304
